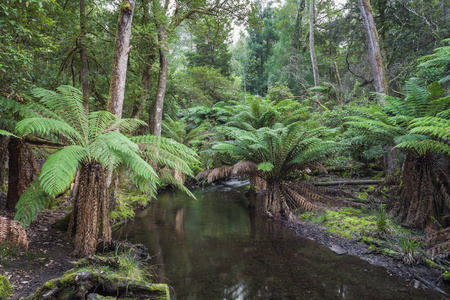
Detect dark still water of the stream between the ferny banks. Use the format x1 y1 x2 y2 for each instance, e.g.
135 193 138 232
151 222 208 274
116 181 441 300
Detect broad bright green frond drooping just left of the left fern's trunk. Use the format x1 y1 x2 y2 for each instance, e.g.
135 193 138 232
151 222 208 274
39 145 88 197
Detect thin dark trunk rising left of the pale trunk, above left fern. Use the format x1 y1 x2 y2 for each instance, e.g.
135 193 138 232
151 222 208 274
80 0 89 114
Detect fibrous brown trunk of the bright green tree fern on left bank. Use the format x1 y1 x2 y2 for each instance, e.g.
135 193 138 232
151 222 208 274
72 164 111 256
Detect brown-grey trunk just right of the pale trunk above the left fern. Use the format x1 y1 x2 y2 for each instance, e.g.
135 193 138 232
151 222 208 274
152 26 168 136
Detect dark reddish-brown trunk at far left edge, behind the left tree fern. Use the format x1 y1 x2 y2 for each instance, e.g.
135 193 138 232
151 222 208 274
6 137 29 211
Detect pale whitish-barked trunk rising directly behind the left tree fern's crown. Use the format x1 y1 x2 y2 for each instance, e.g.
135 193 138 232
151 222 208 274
108 0 135 118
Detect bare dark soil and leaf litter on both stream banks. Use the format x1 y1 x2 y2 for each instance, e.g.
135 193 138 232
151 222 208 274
0 178 450 300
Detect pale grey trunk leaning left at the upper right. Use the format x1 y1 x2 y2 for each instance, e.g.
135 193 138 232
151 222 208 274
358 0 388 95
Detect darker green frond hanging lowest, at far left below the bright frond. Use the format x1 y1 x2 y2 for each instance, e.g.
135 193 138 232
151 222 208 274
14 179 53 228
